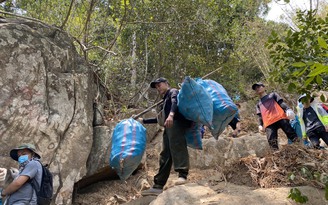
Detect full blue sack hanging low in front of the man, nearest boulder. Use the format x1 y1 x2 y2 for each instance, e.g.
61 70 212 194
109 118 147 180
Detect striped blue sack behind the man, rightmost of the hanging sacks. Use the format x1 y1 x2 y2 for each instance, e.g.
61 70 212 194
195 78 238 139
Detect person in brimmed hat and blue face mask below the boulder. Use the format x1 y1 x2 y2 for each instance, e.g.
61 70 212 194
1 144 42 205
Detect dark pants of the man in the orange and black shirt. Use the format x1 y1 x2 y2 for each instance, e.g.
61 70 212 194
265 119 298 150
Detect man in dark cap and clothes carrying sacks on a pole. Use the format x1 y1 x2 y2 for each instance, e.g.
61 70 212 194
138 77 191 196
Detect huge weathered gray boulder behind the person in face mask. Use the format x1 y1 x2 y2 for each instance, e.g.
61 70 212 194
0 19 96 204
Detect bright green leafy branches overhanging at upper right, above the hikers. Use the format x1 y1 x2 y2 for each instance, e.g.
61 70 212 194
267 10 328 94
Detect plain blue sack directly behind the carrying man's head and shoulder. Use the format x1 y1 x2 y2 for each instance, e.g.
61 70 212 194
178 77 213 128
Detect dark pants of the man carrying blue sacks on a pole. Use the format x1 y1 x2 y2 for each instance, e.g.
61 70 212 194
154 120 190 188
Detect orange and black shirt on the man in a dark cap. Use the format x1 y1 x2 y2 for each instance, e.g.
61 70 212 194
256 92 288 128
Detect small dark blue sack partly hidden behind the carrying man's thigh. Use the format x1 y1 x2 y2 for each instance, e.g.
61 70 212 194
185 122 205 149
